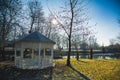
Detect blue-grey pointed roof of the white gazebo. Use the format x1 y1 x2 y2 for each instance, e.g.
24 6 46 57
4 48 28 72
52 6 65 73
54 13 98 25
17 31 55 44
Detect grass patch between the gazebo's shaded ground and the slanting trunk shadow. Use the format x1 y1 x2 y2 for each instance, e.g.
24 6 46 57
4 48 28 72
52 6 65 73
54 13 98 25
53 59 83 80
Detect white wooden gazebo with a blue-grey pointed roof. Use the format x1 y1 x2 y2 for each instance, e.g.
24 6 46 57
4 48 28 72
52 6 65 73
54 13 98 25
15 31 55 69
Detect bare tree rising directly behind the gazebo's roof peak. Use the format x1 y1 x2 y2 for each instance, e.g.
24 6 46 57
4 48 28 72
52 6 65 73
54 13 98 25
28 0 44 33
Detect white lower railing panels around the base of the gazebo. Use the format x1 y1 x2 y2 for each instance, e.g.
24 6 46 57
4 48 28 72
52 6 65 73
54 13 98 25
16 56 53 69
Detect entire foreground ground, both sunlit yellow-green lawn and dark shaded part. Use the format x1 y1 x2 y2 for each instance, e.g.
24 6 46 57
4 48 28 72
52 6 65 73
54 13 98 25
0 58 120 80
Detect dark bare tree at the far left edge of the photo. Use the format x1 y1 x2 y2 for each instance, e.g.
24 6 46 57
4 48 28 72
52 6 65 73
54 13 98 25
0 0 21 58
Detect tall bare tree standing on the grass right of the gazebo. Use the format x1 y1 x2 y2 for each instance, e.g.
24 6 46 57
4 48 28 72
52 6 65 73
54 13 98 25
51 0 87 66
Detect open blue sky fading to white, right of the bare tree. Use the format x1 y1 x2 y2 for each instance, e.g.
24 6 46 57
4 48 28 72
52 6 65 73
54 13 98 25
89 0 120 45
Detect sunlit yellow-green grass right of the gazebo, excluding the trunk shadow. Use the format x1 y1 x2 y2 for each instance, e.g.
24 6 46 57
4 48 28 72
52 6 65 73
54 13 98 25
54 59 120 80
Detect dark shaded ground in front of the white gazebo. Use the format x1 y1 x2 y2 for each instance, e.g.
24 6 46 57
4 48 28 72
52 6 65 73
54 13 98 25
0 64 53 80
